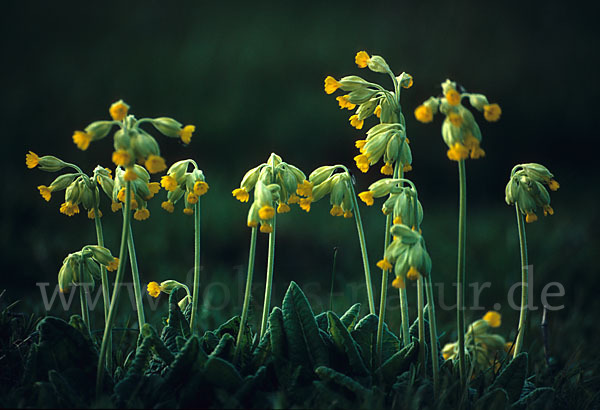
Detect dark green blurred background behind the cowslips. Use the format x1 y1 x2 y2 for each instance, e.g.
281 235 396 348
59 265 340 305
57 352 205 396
0 1 600 364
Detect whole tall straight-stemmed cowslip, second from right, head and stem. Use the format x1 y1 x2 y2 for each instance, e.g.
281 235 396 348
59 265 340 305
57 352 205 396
415 80 502 387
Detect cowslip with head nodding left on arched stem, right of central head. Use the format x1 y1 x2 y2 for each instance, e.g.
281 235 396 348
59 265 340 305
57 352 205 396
308 165 375 314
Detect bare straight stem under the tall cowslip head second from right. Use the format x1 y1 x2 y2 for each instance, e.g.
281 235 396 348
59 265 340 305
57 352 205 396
456 160 467 387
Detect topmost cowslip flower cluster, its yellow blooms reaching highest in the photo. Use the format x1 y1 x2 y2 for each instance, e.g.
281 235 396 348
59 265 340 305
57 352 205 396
325 51 413 175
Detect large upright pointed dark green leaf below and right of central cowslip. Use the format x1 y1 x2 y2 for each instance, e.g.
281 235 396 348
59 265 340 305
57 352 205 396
282 281 328 369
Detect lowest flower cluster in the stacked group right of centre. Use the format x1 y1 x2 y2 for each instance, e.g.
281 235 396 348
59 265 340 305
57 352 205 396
377 224 431 289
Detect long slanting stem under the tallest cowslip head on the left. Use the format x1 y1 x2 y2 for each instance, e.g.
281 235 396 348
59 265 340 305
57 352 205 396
96 181 131 398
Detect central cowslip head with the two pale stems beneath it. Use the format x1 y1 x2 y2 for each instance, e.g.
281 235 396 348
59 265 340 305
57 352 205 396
232 153 313 342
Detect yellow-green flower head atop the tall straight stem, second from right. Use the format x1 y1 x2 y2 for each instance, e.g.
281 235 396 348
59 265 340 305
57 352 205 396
415 79 502 161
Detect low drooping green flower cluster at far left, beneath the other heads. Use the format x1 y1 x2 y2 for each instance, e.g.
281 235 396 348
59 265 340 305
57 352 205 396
58 245 119 293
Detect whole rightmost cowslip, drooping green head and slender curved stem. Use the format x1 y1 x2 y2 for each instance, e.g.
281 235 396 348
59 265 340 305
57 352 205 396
505 163 560 357
